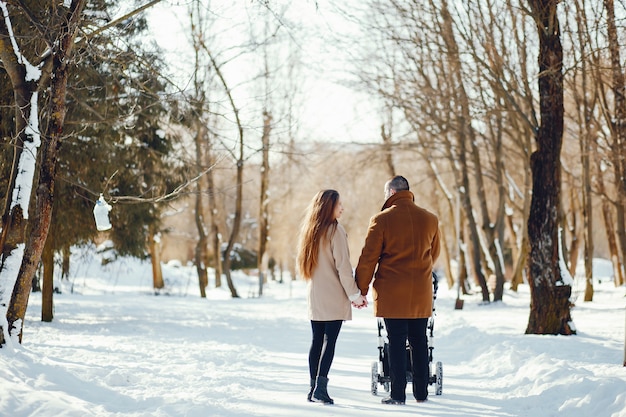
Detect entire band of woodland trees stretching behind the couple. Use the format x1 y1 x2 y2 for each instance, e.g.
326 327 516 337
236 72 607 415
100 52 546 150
0 0 626 345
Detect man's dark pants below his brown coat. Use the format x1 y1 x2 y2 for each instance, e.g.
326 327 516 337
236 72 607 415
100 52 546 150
385 318 430 401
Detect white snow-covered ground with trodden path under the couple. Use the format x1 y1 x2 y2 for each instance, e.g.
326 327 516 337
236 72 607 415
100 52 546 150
0 247 626 417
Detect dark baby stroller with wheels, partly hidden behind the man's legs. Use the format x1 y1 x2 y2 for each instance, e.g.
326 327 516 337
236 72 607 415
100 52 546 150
372 272 443 395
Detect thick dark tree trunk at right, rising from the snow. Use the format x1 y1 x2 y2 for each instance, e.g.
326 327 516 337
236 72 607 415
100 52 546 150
526 0 576 335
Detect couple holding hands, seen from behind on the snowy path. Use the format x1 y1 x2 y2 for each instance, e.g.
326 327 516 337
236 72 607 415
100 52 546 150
297 175 439 404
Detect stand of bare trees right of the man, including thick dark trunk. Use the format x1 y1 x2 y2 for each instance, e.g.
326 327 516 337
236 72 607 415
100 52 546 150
336 0 626 334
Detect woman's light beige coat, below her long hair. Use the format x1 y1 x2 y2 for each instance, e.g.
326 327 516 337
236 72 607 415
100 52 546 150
307 224 359 321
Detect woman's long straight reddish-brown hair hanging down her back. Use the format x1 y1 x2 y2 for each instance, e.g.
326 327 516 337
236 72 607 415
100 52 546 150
297 190 339 279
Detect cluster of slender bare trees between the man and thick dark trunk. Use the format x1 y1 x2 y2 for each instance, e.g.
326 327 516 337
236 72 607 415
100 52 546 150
352 0 552 302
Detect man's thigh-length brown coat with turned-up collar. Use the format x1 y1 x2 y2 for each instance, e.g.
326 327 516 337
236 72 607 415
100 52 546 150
355 191 439 318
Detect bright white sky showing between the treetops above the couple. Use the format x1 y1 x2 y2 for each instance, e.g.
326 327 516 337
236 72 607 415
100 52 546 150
146 0 381 142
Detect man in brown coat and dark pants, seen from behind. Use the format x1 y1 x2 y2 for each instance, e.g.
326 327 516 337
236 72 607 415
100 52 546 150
355 176 439 404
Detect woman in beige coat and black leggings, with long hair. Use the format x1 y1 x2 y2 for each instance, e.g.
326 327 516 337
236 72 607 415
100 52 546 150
298 190 367 404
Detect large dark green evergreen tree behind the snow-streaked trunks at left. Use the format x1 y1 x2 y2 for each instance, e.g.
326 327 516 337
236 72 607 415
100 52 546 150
53 1 180 257
